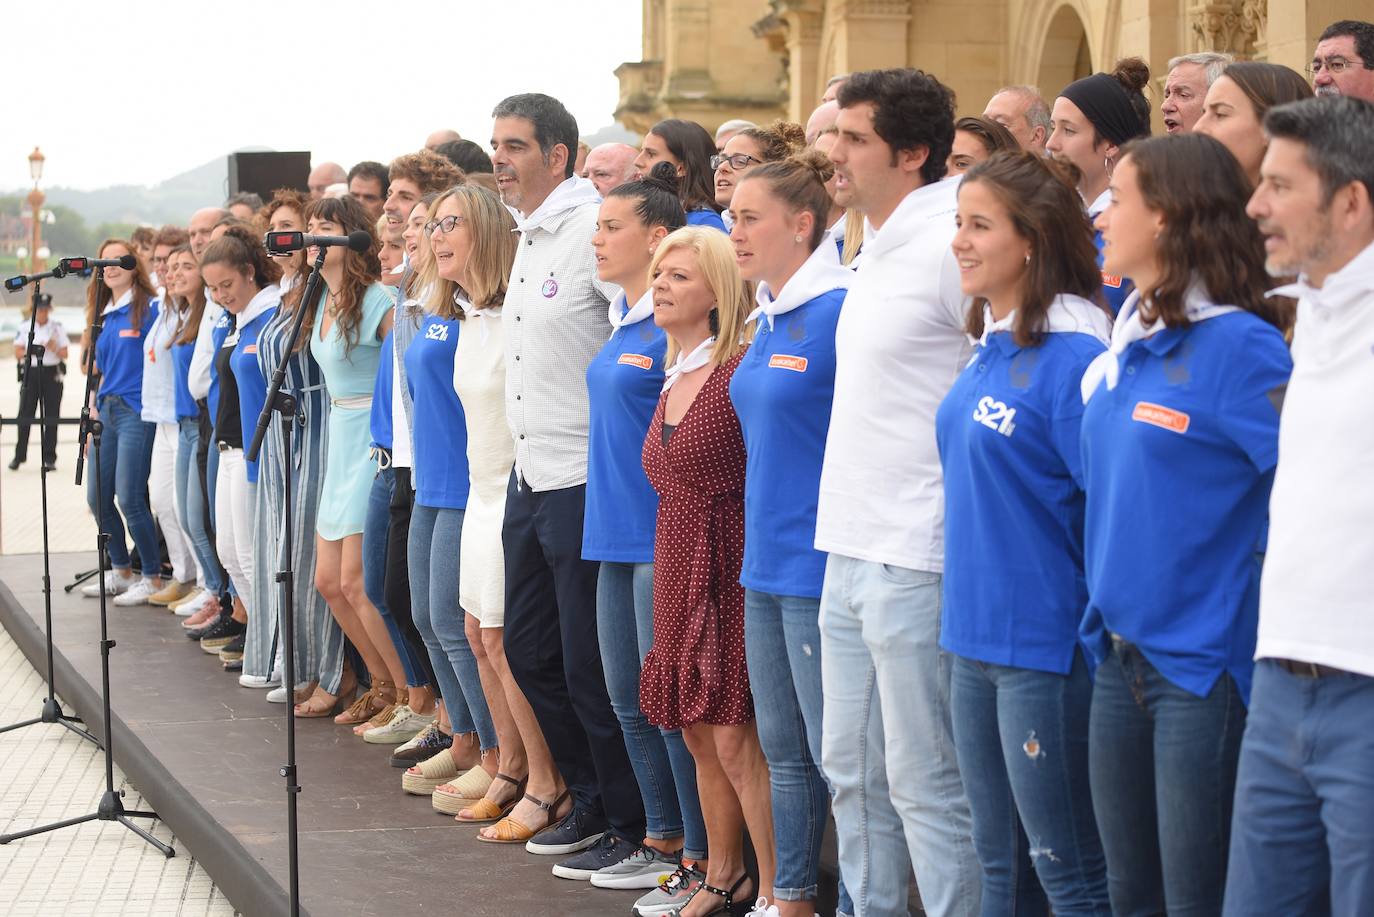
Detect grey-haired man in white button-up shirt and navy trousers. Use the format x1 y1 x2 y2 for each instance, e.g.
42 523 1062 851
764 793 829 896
492 92 644 879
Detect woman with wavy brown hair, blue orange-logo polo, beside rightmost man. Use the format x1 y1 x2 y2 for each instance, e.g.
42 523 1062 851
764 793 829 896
1077 133 1293 914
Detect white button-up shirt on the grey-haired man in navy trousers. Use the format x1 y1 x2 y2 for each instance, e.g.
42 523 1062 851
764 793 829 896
502 177 616 491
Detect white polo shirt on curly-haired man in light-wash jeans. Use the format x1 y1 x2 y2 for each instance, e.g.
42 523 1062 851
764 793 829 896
816 177 970 573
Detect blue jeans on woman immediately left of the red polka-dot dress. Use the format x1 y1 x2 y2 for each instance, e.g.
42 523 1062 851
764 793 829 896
596 561 706 859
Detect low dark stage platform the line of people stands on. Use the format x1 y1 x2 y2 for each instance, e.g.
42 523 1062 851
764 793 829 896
0 553 642 917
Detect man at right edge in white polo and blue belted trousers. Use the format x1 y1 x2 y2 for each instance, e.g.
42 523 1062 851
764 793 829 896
1226 98 1374 917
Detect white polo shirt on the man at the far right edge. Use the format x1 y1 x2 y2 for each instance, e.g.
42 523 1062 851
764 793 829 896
1256 245 1374 676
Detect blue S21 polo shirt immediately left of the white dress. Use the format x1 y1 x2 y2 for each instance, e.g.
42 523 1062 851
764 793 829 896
405 315 469 510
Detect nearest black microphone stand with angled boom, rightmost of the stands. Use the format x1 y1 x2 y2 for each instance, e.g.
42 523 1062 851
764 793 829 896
245 246 327 917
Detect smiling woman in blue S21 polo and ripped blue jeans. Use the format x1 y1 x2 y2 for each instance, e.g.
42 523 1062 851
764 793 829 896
936 151 1112 917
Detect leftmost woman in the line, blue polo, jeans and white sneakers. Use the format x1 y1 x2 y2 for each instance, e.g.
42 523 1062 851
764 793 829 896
81 239 162 599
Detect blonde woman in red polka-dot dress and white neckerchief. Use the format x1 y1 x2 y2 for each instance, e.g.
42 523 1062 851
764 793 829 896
639 227 774 917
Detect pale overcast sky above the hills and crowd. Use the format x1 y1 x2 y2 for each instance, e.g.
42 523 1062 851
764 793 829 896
0 0 642 188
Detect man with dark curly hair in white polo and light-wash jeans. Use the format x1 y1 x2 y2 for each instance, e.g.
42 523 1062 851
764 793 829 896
816 70 981 917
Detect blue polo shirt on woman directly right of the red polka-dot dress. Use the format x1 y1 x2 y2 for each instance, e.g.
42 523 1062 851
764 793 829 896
730 290 846 598
